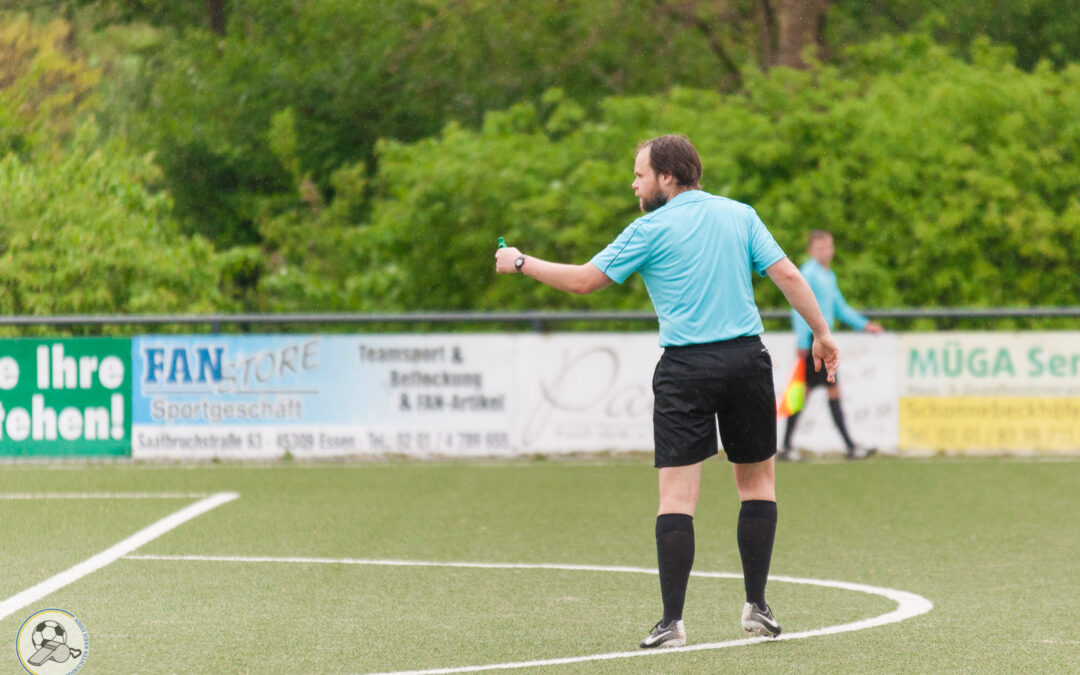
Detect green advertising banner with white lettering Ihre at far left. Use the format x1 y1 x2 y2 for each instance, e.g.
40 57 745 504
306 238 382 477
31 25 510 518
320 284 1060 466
0 338 132 457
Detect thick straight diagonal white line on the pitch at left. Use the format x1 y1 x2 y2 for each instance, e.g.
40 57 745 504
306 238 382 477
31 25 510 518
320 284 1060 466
0 492 240 619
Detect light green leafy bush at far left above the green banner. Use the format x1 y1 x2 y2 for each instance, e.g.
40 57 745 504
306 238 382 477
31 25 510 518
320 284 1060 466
0 126 226 326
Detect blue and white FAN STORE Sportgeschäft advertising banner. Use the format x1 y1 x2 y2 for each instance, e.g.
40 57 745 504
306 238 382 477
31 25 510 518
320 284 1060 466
132 335 513 459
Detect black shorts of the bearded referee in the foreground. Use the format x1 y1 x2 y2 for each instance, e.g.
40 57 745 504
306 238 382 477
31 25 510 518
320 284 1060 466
652 336 777 468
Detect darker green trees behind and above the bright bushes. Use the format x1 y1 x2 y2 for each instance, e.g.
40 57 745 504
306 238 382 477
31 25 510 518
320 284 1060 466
78 0 1080 248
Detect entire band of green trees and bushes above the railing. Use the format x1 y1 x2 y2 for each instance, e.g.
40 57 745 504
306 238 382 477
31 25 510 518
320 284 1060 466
0 0 1080 321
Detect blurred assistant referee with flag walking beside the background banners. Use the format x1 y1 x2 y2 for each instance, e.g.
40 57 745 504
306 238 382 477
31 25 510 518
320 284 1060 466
779 230 883 461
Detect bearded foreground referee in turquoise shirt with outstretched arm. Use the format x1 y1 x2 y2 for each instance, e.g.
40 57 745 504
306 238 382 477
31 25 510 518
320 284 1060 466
495 135 840 648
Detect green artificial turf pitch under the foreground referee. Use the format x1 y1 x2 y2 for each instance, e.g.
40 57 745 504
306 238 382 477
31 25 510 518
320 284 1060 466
0 457 1080 674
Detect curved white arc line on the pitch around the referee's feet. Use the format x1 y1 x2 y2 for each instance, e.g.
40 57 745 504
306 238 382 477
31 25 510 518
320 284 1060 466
116 555 934 675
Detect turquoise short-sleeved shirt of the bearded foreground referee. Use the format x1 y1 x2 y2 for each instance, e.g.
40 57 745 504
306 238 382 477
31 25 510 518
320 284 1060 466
592 190 784 347
